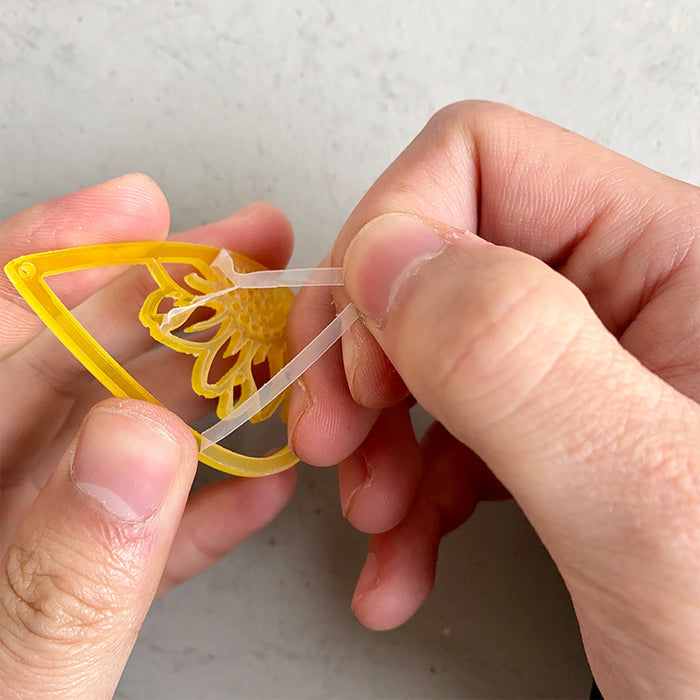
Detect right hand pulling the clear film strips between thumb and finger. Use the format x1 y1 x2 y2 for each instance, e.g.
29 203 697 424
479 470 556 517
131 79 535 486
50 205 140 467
290 103 700 697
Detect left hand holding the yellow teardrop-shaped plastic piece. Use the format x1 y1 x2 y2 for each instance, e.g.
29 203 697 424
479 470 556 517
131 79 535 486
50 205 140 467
0 175 295 698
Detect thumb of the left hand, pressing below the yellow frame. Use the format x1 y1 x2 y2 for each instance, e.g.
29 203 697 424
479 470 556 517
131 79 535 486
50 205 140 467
0 399 197 698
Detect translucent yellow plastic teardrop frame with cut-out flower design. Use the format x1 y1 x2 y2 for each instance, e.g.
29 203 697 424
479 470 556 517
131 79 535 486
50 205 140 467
5 241 298 476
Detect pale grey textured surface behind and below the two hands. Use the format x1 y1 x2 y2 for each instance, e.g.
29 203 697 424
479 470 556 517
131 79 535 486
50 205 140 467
0 0 700 700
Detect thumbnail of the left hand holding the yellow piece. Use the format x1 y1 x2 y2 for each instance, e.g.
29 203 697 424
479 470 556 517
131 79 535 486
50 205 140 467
71 408 182 522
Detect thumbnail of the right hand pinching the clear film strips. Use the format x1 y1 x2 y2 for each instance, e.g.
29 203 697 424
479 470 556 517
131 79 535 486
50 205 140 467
344 214 445 325
